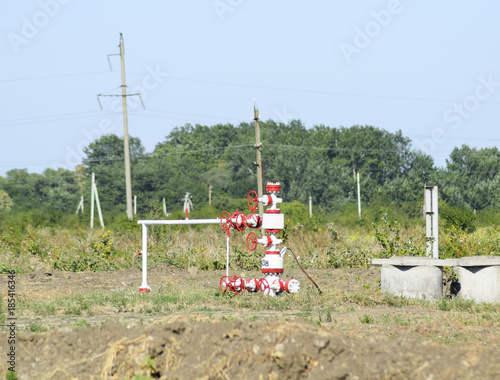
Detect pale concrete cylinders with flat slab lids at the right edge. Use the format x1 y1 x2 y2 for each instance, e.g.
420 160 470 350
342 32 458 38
372 256 500 303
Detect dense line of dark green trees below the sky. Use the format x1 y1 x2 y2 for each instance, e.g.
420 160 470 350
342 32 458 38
0 120 500 221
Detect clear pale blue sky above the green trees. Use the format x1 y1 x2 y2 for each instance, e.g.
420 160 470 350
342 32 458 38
0 0 500 175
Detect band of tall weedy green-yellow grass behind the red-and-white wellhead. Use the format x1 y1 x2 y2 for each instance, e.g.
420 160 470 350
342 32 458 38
0 220 500 276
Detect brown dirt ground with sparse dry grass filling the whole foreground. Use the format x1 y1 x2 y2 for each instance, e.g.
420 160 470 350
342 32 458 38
0 265 500 379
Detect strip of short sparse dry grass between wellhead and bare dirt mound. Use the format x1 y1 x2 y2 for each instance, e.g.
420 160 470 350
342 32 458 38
17 271 500 346
